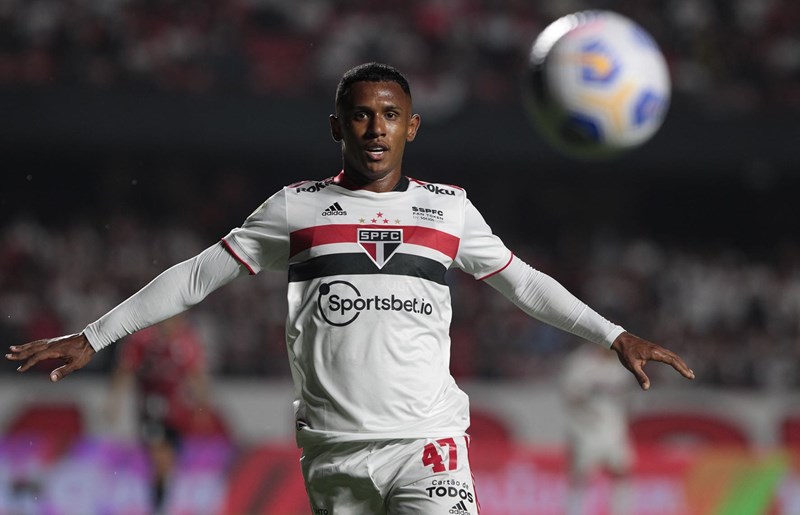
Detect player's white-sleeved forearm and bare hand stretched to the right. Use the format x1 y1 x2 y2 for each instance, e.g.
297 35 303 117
486 257 694 390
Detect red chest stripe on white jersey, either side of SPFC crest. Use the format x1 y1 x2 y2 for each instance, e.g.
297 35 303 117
289 224 460 259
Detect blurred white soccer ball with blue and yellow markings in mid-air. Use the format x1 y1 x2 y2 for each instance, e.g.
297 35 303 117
524 11 671 159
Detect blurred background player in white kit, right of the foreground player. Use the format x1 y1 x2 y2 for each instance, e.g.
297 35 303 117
559 345 634 515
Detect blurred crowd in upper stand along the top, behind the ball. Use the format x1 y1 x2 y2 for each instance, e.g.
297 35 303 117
0 0 800 116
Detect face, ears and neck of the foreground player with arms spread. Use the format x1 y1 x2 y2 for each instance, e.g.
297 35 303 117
330 82 419 191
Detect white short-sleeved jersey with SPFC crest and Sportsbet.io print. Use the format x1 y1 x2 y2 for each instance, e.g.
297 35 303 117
223 174 512 446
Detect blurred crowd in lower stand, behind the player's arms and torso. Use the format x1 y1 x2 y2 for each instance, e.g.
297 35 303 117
0 189 800 389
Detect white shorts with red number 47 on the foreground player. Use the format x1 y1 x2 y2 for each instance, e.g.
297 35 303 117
300 436 479 515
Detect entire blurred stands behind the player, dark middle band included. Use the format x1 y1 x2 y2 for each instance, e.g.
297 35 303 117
0 0 800 389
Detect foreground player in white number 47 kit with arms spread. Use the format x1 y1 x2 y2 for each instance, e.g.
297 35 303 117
6 63 694 515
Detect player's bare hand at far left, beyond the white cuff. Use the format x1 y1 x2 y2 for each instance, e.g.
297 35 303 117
6 333 96 382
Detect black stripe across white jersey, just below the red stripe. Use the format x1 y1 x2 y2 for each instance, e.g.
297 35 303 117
289 252 447 285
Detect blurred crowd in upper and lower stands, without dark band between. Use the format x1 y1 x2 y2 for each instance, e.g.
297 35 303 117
0 0 800 388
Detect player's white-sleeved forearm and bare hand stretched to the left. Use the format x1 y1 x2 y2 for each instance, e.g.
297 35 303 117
6 244 247 381
